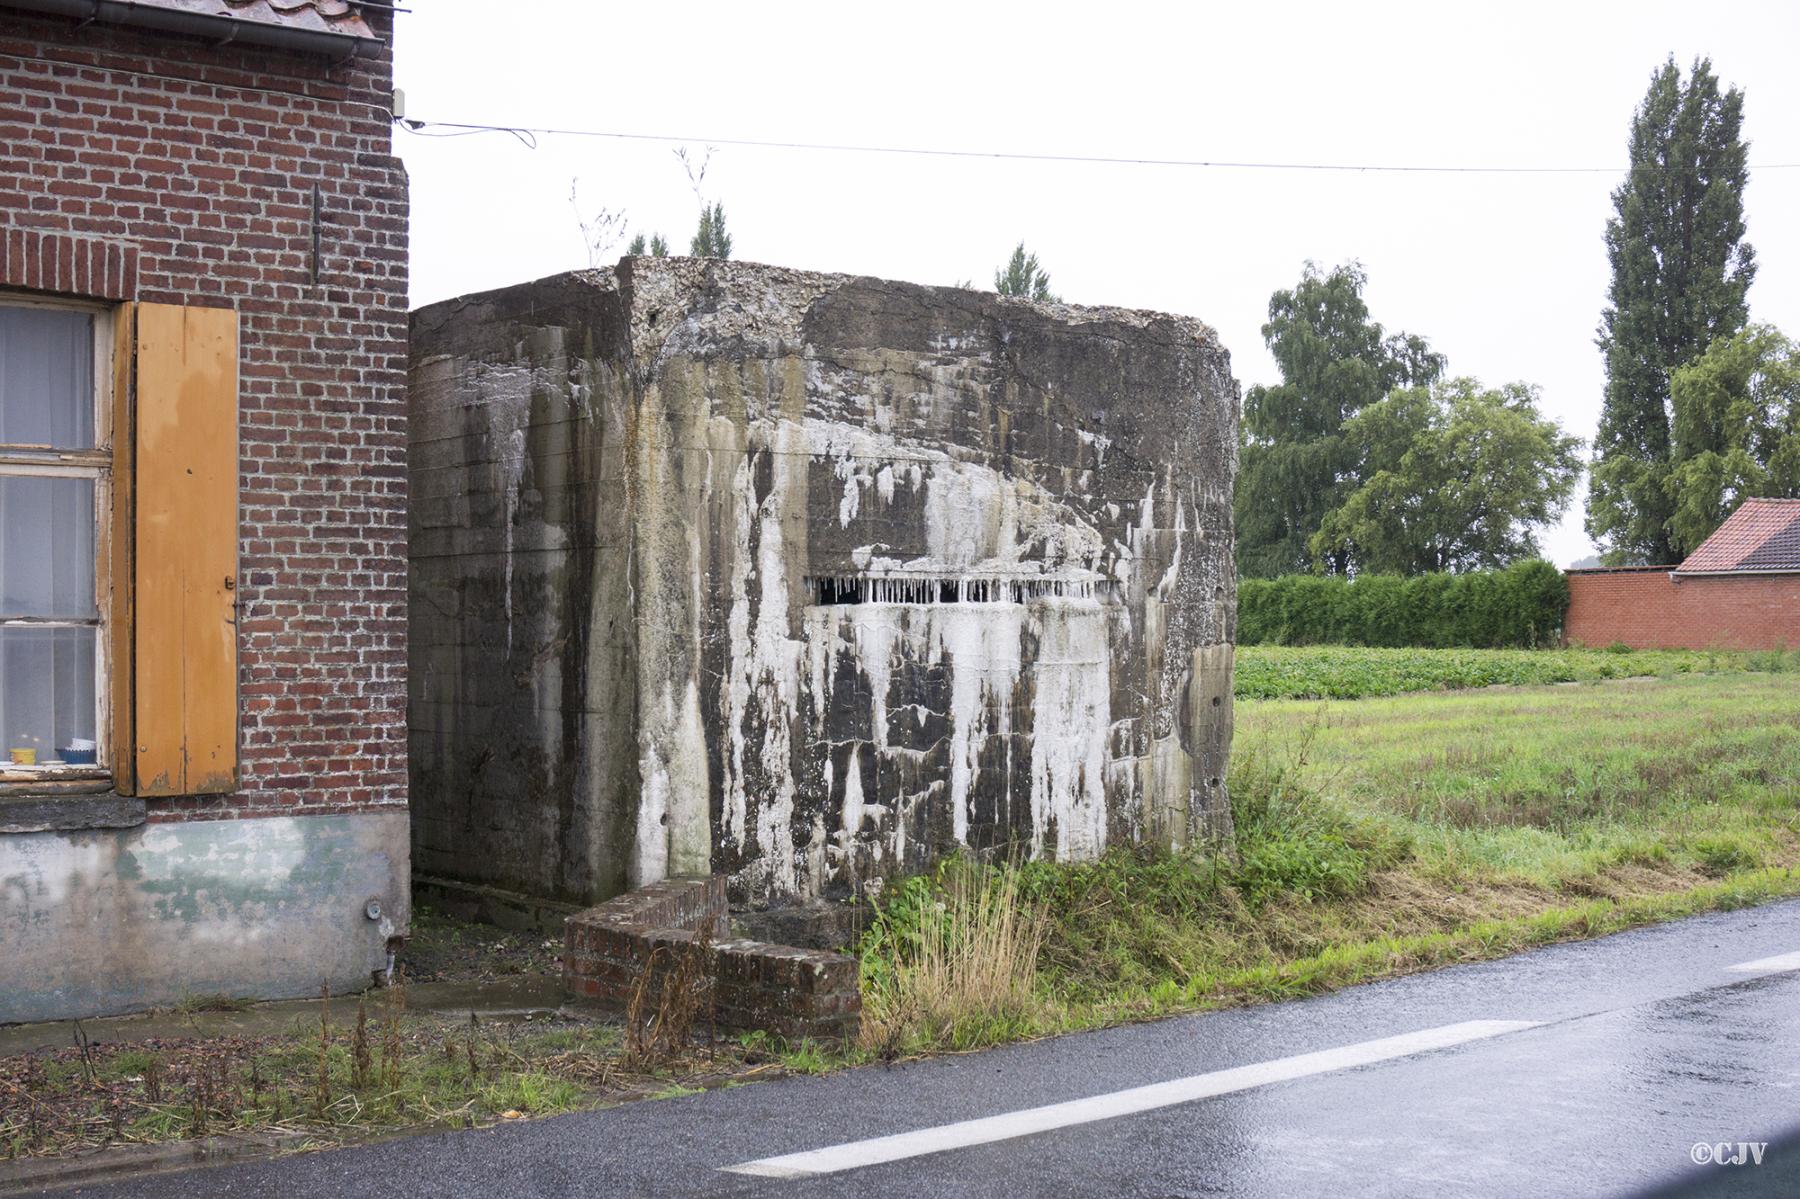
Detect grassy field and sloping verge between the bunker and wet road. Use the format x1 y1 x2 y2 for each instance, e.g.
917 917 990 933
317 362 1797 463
864 673 1800 1055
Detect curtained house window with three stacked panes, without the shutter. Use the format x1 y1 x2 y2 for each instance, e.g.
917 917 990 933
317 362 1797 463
0 297 113 781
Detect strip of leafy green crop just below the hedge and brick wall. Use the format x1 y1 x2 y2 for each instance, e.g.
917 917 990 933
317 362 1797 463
1235 645 1800 699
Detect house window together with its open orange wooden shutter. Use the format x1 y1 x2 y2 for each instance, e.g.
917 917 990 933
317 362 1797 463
0 295 238 796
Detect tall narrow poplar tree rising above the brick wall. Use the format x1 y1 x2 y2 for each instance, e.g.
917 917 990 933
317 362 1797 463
1588 56 1757 565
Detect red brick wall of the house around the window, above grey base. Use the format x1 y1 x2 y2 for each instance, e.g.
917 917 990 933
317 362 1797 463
0 5 407 819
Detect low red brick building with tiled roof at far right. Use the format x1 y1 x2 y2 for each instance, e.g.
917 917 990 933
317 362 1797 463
1562 499 1800 650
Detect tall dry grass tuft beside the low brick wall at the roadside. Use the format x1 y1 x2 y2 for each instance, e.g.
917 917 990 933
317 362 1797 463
862 859 1046 1057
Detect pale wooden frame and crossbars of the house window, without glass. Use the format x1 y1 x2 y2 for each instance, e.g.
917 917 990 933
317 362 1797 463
0 292 117 794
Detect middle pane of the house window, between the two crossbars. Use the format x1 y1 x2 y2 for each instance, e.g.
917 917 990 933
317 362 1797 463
0 475 99 621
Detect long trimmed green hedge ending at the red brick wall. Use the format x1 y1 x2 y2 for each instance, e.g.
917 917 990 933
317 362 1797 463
1237 558 1570 648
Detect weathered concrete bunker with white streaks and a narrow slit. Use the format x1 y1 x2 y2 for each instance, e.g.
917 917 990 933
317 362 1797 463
410 259 1238 906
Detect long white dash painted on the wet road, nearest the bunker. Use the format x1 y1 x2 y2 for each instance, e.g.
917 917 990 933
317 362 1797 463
722 1021 1537 1177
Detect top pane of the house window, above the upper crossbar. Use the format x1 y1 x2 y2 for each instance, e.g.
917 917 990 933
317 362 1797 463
0 304 94 450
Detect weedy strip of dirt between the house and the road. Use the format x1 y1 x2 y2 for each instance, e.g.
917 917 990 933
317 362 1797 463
0 999 783 1159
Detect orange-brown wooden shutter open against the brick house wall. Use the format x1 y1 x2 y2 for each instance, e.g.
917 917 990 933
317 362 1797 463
119 304 238 796
